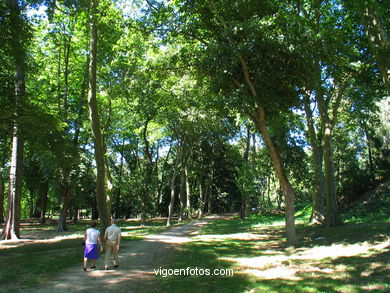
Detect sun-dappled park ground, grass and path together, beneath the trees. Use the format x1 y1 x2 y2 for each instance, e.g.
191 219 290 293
0 210 390 293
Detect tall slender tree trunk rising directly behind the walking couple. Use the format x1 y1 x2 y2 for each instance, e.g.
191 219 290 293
88 0 111 231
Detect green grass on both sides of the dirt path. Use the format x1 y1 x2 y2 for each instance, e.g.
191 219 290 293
0 185 390 293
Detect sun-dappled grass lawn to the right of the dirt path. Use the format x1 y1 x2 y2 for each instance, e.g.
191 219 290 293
160 215 390 293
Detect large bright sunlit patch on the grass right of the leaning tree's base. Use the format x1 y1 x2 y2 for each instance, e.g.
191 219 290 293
219 235 390 281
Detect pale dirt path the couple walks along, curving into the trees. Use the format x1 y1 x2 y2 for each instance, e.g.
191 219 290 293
28 219 210 293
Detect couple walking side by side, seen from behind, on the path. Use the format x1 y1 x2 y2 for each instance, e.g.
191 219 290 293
83 219 121 271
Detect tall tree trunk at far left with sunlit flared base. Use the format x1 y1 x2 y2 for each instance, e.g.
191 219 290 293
0 0 26 239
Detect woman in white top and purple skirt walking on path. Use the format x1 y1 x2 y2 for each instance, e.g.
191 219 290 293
83 222 103 272
